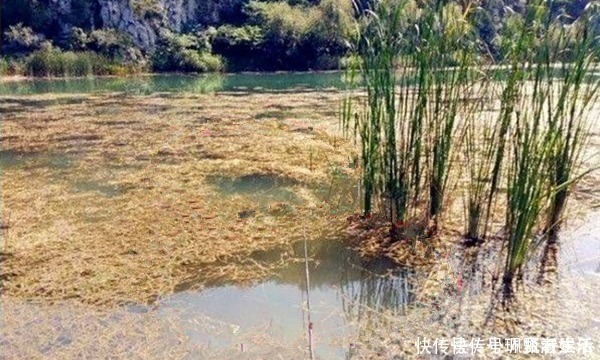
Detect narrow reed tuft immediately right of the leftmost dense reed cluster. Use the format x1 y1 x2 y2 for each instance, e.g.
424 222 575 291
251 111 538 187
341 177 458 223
417 1 475 220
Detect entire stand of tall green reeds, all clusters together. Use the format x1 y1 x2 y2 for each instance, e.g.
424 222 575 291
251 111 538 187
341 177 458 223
342 1 599 298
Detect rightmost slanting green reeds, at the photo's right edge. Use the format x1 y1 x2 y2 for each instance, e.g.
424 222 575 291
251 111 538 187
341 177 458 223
542 10 600 271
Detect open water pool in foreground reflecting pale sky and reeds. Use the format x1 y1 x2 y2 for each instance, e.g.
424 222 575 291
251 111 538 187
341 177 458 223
162 241 422 359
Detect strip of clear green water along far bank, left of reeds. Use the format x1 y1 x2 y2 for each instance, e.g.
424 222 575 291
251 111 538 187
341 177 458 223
0 72 344 95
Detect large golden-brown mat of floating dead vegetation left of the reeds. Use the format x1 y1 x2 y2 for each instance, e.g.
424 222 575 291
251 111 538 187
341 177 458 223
1 93 354 305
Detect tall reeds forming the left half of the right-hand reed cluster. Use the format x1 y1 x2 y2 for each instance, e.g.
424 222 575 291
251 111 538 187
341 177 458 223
502 1 550 301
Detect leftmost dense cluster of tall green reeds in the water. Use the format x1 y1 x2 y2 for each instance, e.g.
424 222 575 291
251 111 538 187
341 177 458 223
342 2 406 222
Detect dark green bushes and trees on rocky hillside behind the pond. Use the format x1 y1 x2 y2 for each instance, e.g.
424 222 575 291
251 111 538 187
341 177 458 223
1 0 600 73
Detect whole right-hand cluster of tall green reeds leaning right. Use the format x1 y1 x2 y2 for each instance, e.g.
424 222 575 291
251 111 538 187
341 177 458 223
503 2 598 299
